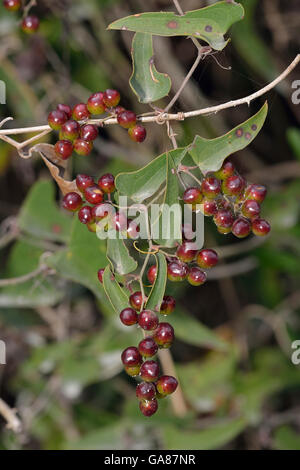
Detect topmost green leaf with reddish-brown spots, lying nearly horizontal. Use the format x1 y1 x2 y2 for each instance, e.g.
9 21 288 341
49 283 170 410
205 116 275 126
108 1 244 50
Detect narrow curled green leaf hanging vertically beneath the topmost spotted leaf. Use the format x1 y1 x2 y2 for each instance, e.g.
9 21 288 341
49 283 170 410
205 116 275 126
129 33 171 103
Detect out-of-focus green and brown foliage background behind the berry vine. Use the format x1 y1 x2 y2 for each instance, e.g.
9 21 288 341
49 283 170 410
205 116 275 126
0 0 300 449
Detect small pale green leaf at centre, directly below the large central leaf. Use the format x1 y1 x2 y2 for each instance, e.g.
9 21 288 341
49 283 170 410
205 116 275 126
106 239 137 275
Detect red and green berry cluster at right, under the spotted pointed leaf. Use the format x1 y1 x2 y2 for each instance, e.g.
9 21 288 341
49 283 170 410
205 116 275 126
183 161 271 238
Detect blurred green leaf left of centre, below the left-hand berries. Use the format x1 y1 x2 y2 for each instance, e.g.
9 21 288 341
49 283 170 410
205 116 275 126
46 217 107 300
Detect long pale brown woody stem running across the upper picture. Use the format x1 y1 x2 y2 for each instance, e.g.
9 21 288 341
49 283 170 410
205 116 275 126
0 54 300 142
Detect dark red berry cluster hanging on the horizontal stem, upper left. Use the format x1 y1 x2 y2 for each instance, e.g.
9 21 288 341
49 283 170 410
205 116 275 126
48 89 146 160
